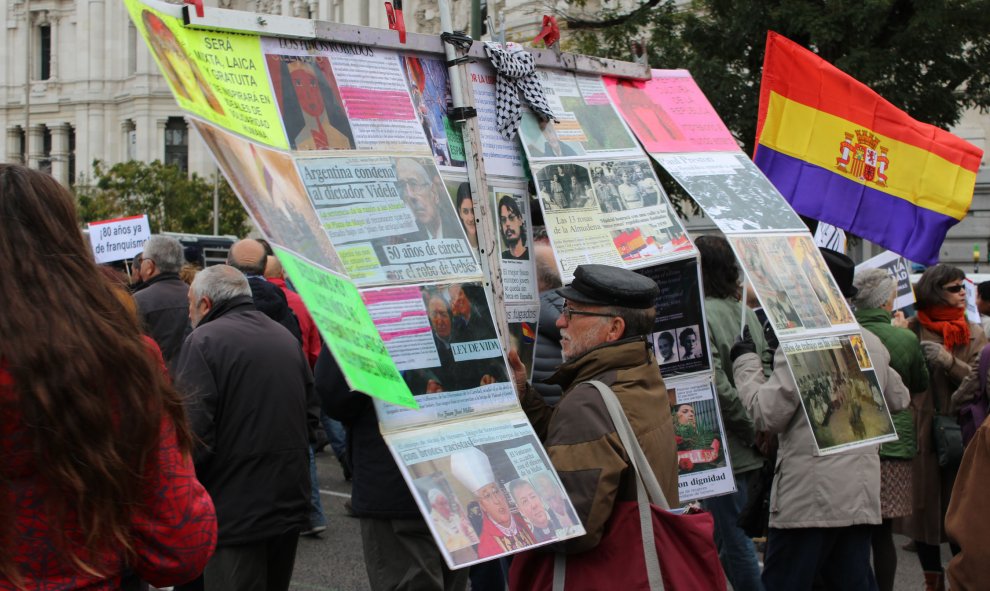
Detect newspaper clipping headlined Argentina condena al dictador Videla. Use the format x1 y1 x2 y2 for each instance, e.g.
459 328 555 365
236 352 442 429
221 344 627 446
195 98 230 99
297 156 481 286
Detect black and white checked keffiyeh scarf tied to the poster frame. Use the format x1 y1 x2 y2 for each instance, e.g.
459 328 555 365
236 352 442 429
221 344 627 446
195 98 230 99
485 42 557 140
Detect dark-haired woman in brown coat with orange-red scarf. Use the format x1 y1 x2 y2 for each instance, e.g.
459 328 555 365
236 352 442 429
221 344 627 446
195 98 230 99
897 264 987 591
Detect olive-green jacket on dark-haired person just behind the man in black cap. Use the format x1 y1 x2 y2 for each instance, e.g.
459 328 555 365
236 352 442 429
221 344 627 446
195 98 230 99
705 298 772 474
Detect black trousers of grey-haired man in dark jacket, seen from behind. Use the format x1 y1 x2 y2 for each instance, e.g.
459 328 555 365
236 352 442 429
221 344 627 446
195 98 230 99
203 530 299 591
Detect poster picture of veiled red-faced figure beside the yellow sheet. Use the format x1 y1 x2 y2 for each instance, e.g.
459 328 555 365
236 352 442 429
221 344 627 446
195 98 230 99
265 54 355 150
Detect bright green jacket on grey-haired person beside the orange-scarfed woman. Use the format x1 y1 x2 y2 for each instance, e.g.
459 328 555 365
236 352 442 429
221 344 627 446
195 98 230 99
854 308 928 459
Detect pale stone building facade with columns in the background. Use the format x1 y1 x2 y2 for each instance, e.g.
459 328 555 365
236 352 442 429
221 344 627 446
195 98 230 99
0 0 990 268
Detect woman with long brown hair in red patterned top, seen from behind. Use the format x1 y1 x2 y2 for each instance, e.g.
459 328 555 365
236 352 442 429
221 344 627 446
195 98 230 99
0 165 216 589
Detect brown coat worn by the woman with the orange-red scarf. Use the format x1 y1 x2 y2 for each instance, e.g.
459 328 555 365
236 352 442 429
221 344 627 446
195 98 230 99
895 319 987 544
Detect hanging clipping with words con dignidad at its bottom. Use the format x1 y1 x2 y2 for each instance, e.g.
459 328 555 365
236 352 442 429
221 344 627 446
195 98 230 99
666 375 736 503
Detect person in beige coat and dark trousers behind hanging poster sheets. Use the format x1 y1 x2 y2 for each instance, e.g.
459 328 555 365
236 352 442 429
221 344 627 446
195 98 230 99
730 251 910 591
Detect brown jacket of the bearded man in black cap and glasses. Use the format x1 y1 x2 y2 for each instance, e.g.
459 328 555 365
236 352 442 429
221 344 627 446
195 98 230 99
522 338 678 553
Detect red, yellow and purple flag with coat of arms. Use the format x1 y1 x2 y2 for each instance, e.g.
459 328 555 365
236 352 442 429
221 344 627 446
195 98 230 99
754 32 983 264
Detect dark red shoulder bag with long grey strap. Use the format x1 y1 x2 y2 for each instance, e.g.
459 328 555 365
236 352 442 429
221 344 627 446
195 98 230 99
509 381 726 591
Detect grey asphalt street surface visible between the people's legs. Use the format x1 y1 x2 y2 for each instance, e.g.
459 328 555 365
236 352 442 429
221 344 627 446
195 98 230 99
290 448 949 591
